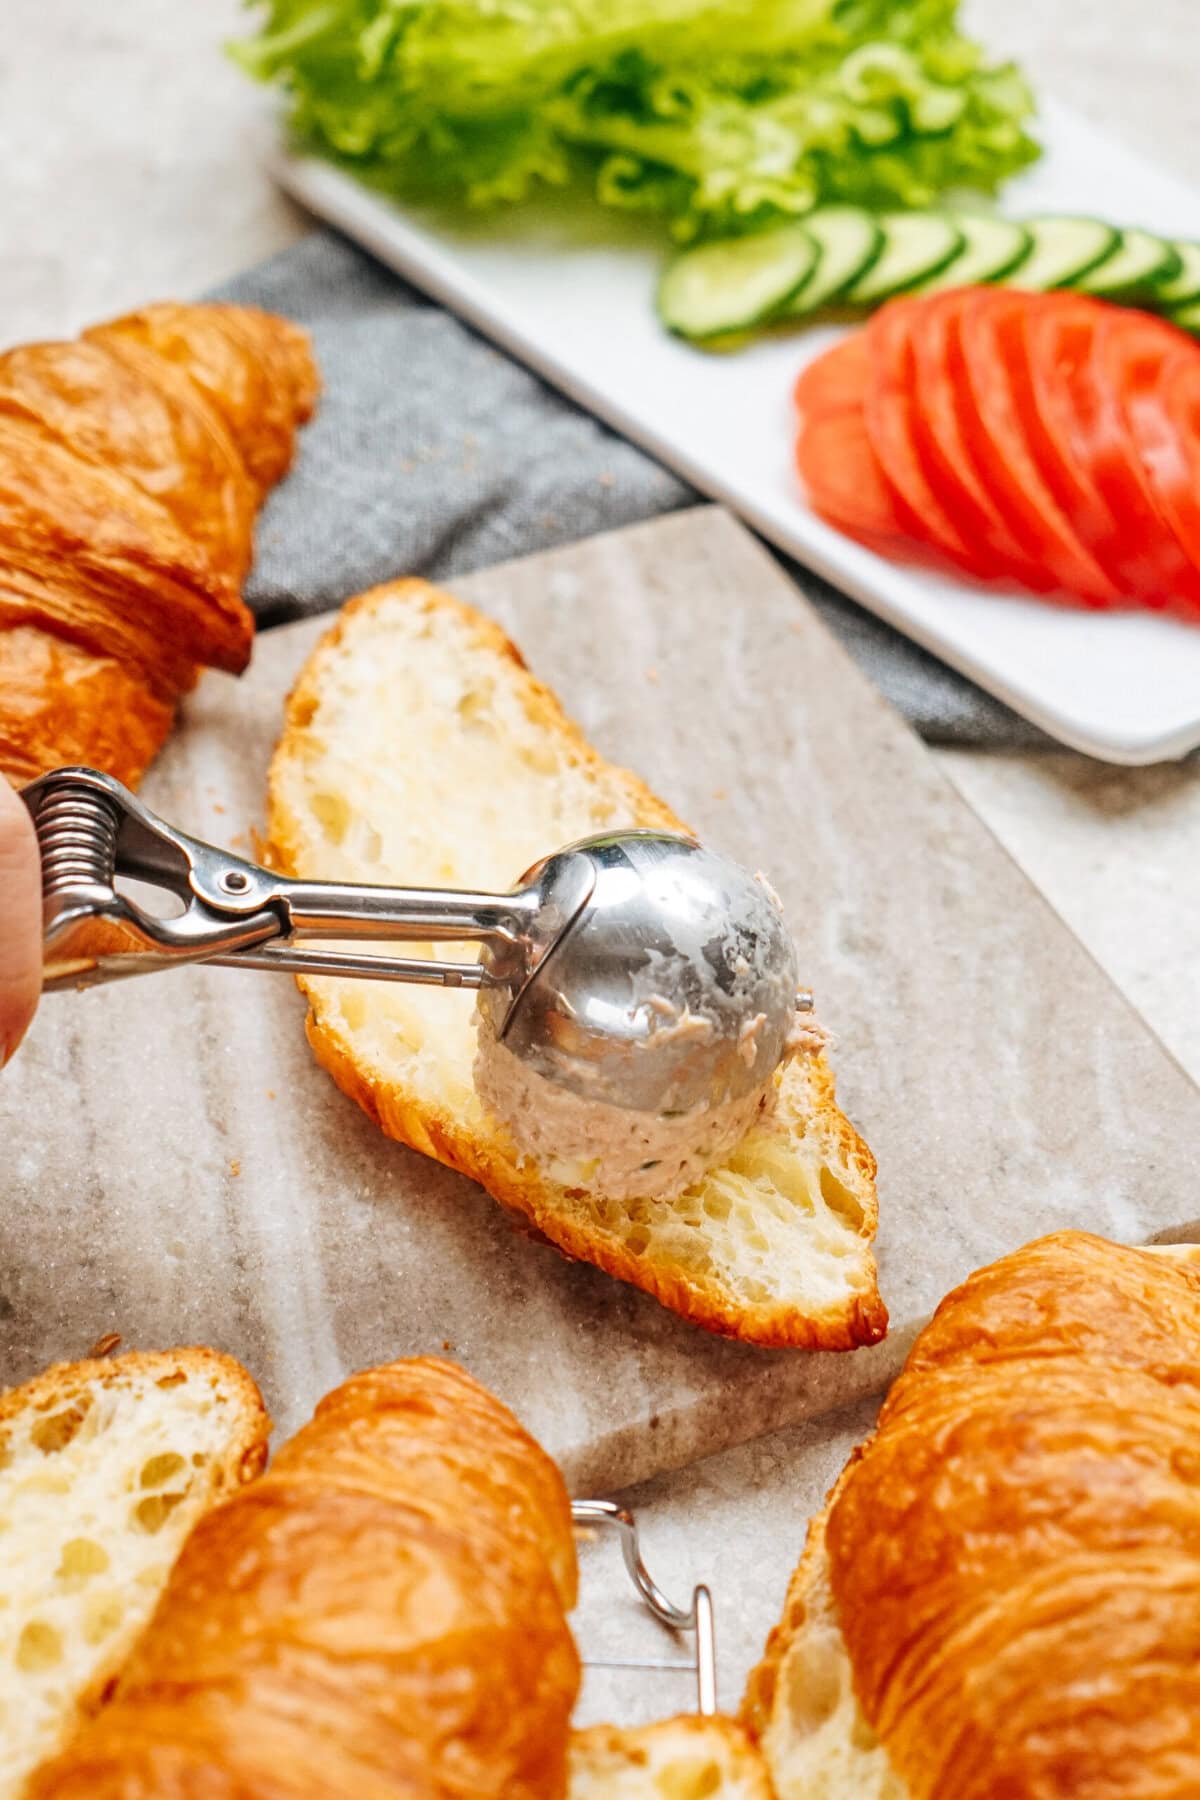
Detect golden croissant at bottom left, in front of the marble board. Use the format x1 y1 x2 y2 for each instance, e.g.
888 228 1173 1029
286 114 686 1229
27 1359 579 1800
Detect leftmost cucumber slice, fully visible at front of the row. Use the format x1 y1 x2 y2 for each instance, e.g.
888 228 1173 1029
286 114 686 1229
658 225 819 338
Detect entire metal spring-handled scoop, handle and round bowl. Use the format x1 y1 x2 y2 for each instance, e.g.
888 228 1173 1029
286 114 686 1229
23 769 811 1114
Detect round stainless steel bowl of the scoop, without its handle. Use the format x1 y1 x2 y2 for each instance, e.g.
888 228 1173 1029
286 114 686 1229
480 832 797 1114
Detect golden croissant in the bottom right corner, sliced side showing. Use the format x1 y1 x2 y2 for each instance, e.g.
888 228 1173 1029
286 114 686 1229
745 1233 1200 1800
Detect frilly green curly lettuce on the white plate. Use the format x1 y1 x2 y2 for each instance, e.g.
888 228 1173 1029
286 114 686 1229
234 0 1038 239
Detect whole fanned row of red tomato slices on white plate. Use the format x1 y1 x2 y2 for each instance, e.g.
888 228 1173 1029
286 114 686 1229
795 288 1200 616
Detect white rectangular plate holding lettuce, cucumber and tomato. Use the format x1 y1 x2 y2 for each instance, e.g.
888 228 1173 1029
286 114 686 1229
270 108 1200 763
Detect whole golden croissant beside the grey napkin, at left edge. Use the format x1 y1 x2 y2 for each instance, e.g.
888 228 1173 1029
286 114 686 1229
0 304 317 783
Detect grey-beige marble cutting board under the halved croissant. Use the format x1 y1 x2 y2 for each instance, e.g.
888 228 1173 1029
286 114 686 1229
0 508 1200 1492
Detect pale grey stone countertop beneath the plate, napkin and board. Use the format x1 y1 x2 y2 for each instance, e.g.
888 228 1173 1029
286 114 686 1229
0 0 1200 1742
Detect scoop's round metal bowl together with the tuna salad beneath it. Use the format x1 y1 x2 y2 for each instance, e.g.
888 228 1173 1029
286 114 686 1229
475 832 815 1199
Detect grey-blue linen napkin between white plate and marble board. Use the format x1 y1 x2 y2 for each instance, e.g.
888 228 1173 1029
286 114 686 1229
219 230 1049 747
